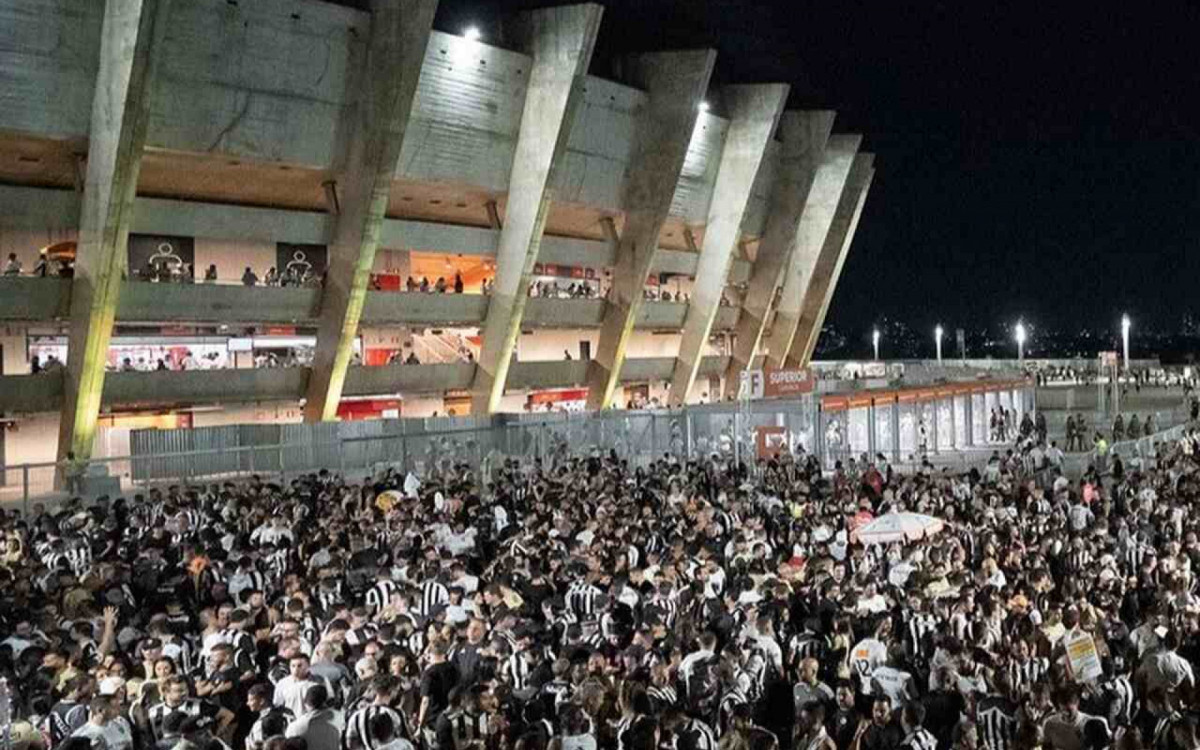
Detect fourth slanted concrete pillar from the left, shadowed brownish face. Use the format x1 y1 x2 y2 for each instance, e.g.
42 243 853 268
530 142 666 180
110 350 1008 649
588 49 716 409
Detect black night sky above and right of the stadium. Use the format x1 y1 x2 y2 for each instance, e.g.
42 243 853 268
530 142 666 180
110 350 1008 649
350 0 1200 335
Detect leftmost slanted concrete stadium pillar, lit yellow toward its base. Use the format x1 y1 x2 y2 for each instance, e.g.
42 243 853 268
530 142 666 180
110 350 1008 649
58 0 170 458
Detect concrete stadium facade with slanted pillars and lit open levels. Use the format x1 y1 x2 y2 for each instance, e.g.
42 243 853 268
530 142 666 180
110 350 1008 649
0 0 874 456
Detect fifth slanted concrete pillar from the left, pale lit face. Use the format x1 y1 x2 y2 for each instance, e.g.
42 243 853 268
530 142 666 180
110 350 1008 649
668 84 788 407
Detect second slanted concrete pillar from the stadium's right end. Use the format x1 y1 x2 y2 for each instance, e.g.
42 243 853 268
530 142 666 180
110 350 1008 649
767 136 863 368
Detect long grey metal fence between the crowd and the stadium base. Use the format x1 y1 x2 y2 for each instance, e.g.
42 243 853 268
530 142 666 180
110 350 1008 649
0 396 818 508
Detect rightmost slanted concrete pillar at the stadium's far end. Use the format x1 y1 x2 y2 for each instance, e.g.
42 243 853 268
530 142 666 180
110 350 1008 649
787 154 875 367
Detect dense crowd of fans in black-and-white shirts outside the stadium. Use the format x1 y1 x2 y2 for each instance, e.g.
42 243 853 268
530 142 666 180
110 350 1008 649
7 417 1200 750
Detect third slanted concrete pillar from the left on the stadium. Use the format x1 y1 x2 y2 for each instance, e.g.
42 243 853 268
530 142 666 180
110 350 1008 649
470 4 604 414
